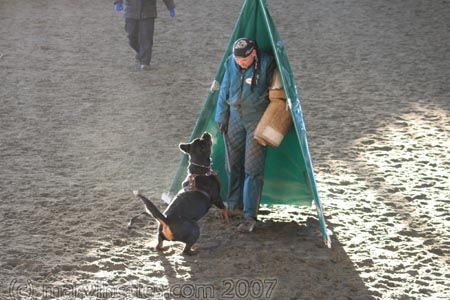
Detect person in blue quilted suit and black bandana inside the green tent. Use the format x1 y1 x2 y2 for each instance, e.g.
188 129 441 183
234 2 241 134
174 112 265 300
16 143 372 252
215 38 275 232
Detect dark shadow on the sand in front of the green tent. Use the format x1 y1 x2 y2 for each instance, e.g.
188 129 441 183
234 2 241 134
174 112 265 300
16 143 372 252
152 209 376 299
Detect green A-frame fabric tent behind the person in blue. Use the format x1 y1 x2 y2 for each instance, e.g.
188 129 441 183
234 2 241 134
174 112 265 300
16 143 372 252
165 0 331 246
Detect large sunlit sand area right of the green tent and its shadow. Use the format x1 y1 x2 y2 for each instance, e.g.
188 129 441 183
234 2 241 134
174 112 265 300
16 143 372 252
317 106 450 298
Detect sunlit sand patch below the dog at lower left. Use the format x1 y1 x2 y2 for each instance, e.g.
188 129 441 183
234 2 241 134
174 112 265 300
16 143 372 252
41 234 191 299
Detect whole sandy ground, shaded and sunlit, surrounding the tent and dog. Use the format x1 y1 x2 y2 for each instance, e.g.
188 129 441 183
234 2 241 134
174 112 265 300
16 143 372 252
0 0 450 299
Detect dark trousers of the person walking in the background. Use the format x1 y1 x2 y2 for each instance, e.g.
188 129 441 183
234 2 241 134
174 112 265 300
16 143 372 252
125 18 155 65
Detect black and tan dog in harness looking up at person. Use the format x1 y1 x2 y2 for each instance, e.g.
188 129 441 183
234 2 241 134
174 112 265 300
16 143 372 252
130 132 228 254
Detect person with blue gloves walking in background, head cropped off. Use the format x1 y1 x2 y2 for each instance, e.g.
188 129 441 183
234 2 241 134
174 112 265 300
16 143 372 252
114 0 176 70
